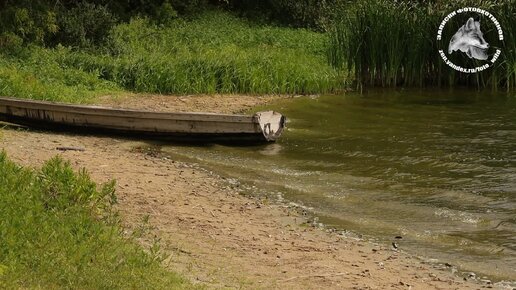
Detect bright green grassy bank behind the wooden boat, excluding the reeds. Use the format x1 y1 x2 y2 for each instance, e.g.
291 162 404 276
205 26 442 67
0 11 345 102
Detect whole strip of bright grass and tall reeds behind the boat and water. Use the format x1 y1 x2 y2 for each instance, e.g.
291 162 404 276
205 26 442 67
0 0 516 102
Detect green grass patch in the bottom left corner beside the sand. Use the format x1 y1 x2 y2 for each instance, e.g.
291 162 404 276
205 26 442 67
0 152 191 289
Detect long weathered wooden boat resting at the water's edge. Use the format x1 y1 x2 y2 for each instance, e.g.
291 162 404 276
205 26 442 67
0 97 285 142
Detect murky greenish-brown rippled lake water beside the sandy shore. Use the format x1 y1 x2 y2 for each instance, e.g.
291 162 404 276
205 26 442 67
166 90 516 281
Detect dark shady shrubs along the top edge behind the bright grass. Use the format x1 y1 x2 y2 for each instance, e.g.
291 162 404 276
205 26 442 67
0 0 340 47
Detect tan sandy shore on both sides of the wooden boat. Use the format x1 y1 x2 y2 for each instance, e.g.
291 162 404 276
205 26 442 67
0 96 491 289
